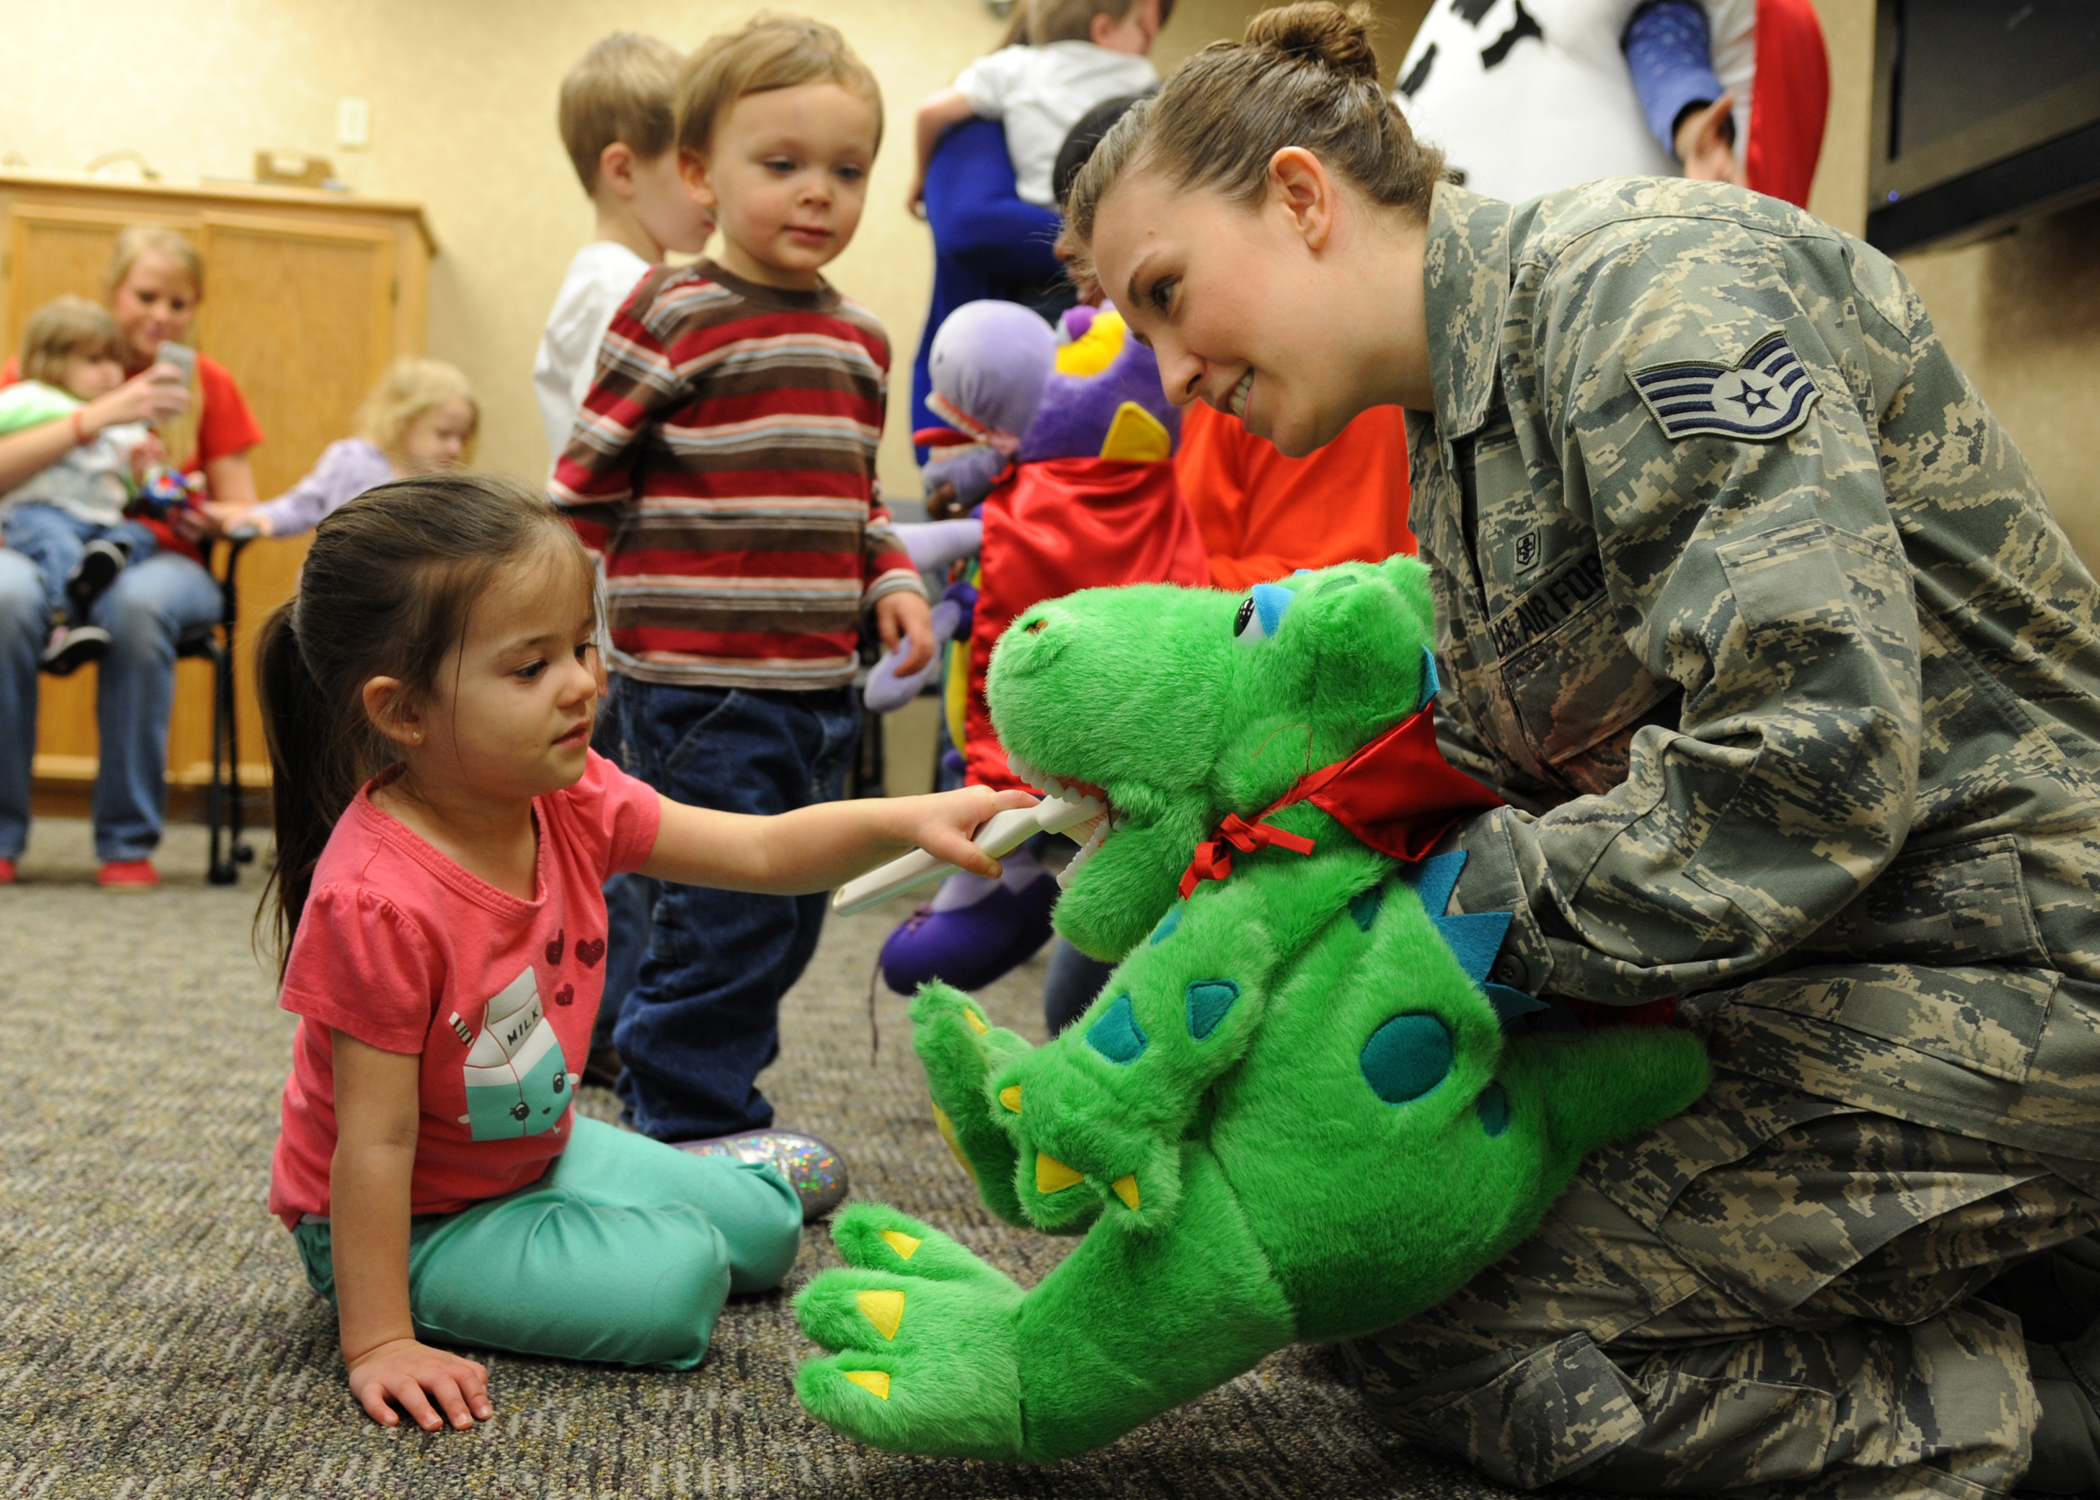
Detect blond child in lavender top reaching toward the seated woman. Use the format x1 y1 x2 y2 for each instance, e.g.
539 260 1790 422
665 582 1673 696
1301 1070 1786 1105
204 355 481 536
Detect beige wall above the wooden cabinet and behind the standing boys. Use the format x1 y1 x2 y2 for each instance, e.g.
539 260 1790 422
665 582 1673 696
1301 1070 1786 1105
0 0 1420 496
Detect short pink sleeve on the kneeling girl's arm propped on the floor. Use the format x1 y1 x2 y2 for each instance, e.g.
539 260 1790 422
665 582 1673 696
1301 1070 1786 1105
277 884 445 1053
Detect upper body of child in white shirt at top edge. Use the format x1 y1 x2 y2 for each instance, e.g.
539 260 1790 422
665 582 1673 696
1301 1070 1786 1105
907 0 1174 212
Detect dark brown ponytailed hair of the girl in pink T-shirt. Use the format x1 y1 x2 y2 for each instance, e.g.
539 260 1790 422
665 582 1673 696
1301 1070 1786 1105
243 473 592 979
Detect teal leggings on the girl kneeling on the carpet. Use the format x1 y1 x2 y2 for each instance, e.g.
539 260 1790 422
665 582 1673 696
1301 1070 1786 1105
292 1118 802 1370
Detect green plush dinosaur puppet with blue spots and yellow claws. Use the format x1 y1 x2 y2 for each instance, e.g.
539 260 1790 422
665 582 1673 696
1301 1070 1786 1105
796 559 1707 1462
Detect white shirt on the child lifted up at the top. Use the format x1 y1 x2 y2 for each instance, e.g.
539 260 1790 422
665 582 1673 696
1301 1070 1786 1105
956 42 1159 208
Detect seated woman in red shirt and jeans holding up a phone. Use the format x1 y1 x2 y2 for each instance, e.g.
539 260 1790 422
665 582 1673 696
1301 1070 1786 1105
0 225 263 891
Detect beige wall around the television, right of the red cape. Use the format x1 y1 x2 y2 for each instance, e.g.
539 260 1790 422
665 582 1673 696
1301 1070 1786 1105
1808 0 2100 565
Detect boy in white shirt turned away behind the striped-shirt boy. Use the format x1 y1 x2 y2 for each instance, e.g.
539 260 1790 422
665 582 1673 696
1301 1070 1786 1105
531 32 714 458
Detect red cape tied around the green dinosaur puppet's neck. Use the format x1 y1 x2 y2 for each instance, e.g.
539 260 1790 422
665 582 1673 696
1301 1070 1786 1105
1180 704 1502 899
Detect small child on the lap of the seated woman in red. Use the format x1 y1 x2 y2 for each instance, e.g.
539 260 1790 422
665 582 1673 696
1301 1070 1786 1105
0 296 160 676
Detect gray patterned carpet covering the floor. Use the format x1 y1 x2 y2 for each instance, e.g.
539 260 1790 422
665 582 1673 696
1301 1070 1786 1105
0 819 1504 1500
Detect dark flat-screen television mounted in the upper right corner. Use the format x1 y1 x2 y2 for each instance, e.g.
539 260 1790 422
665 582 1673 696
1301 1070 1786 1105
1867 0 2100 254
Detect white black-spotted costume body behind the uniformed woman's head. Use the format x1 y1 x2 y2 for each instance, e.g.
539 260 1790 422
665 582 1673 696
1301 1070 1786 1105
1392 0 1758 204
